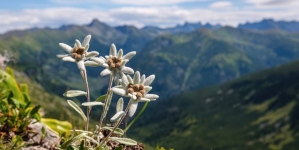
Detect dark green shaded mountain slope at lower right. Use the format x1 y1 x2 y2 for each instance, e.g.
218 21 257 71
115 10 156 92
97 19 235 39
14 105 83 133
129 61 299 150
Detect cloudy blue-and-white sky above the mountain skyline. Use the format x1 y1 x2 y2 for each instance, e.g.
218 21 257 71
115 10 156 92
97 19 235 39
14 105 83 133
0 0 299 33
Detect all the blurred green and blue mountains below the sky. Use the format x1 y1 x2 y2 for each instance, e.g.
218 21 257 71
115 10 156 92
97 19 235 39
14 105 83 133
0 20 299 150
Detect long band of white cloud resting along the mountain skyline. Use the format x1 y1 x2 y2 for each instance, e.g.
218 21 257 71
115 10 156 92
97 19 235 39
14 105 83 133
0 6 299 33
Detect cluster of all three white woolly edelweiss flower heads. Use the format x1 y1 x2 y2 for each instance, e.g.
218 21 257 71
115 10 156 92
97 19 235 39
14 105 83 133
57 35 159 117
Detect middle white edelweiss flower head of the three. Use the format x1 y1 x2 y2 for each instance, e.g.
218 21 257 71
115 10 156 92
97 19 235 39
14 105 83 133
90 44 136 84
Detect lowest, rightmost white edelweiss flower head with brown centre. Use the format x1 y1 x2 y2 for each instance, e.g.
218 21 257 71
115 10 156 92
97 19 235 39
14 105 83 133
111 71 159 117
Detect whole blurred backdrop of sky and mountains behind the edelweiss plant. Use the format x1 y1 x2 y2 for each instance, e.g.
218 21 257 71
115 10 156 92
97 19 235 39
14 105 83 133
0 0 299 150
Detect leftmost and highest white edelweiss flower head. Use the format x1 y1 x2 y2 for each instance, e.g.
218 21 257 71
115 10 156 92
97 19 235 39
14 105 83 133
57 35 99 71
